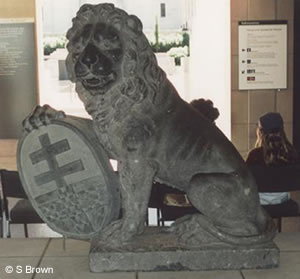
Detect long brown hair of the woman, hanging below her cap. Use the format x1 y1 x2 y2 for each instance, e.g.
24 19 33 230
255 127 297 165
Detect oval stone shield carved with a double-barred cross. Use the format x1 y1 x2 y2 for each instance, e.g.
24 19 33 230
17 116 120 239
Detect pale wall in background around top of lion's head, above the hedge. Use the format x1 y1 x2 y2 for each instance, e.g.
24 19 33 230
43 0 184 34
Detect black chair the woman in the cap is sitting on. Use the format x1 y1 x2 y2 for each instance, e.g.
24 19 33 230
250 165 300 232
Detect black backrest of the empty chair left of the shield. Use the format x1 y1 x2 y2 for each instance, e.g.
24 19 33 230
0 169 27 201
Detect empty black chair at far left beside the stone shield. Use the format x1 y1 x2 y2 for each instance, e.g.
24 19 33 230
0 169 44 237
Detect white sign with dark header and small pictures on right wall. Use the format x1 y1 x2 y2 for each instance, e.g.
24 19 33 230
239 20 287 90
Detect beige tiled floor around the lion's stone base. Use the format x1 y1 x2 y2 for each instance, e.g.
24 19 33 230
0 233 300 279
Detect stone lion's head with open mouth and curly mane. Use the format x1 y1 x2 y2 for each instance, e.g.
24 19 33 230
67 4 165 111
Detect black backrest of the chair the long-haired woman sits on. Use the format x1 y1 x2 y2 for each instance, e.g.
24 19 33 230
249 164 300 192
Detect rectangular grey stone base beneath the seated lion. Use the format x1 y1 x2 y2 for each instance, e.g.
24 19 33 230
89 231 279 272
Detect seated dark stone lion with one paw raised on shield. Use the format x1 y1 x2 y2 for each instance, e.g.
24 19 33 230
23 4 275 246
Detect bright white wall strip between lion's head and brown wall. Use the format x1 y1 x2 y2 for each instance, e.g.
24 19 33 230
186 0 231 139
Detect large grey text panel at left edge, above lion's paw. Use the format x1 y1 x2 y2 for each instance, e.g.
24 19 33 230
0 20 37 138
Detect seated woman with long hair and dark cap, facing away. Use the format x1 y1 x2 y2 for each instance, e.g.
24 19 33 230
246 112 298 205
